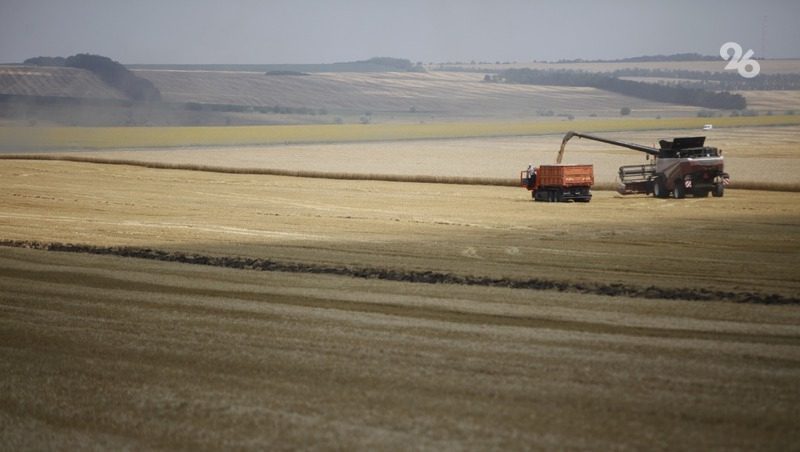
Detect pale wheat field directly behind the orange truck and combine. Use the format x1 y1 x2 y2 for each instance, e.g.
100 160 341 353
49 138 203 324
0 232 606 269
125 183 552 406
50 120 800 190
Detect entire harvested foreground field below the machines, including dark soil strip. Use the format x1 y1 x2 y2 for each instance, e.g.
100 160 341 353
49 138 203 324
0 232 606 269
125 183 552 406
0 160 800 450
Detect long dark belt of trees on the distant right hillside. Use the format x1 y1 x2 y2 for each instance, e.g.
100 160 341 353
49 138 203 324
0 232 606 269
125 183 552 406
496 69 747 110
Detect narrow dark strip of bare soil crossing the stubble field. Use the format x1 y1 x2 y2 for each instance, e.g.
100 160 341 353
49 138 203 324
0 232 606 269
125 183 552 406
0 240 800 305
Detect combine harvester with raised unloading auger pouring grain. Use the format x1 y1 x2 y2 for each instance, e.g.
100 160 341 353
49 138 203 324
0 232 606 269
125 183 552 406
556 132 730 199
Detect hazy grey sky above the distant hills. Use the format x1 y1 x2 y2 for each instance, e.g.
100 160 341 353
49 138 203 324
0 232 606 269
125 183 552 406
0 0 800 64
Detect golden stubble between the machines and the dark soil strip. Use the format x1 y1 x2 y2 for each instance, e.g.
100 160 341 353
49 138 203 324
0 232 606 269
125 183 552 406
0 160 800 295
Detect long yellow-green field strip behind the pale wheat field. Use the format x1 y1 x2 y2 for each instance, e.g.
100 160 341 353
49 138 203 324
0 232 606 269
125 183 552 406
0 115 800 150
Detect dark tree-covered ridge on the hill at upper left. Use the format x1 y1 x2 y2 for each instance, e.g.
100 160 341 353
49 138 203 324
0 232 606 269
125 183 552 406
23 53 161 102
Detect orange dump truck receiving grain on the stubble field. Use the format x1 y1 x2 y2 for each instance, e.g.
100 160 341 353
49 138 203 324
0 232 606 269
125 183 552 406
519 165 594 202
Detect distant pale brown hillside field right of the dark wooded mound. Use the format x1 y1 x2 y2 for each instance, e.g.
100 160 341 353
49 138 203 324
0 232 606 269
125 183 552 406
136 70 696 121
